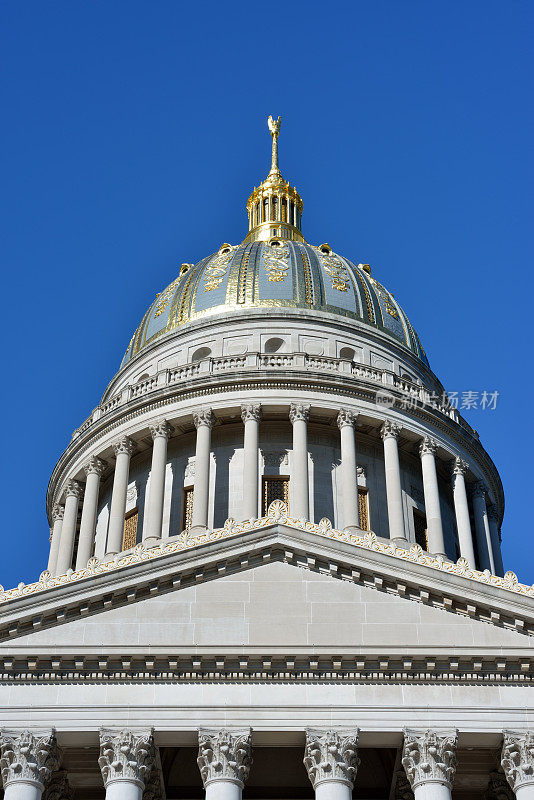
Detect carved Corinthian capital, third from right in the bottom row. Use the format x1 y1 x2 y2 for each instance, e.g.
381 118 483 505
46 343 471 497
304 728 360 789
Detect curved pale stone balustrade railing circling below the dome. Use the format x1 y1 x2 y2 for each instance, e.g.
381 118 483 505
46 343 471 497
72 353 474 439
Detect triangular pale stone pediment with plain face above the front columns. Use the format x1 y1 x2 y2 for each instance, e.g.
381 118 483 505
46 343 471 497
0 523 534 675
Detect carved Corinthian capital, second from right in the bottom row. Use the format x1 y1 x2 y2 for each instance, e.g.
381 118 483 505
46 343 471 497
402 730 458 790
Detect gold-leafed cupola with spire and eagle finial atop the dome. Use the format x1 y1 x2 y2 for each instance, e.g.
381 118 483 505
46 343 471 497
245 117 305 242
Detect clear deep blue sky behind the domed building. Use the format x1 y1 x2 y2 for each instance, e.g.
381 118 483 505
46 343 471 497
0 0 534 587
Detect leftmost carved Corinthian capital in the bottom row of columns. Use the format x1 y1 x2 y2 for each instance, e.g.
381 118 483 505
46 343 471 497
0 730 59 789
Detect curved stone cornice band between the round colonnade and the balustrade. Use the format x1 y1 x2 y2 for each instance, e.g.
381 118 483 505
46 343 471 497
46 359 504 520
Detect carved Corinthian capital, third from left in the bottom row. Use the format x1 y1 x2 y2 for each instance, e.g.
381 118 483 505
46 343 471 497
197 728 252 787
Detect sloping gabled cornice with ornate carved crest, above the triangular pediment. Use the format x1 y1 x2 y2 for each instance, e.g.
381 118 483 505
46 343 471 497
0 501 534 645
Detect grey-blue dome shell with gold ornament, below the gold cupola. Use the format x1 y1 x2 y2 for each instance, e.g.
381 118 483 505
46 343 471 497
122 239 427 365
